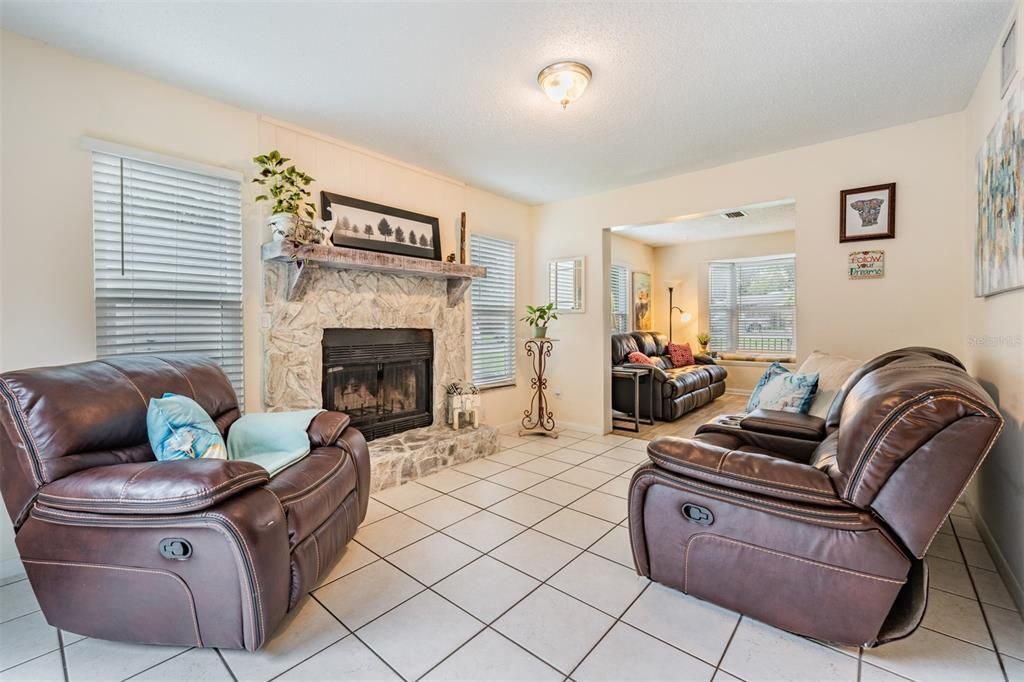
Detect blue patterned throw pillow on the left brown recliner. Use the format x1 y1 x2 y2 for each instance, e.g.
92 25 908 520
145 393 227 460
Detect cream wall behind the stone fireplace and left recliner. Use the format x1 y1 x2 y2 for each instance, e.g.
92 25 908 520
0 32 532 574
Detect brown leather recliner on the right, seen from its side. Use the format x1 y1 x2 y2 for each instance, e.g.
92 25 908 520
630 348 1002 646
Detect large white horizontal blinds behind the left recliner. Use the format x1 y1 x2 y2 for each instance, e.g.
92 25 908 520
92 152 243 400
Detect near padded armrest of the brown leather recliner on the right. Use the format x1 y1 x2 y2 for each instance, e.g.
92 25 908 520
647 436 848 507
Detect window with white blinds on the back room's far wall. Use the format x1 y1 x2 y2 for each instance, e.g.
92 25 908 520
708 255 797 353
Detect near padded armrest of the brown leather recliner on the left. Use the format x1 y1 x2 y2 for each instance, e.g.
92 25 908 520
39 459 270 514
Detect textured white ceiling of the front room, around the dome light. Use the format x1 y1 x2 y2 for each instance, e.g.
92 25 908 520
0 0 1011 203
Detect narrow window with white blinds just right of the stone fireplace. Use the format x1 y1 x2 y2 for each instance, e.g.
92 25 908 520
469 235 516 387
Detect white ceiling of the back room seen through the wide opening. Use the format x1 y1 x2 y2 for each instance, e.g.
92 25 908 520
613 201 797 247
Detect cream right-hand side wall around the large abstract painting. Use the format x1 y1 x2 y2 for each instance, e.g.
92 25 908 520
962 0 1024 609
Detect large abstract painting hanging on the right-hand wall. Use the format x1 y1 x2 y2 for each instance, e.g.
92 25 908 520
974 83 1024 296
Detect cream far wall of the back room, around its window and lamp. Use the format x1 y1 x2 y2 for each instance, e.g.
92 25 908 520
654 230 800 391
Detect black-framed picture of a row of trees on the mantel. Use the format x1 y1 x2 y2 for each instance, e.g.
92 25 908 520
321 191 441 260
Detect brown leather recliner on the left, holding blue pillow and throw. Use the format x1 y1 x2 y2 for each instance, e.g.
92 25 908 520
0 355 370 650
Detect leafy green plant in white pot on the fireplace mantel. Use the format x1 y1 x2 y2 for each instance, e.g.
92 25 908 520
253 150 322 244
